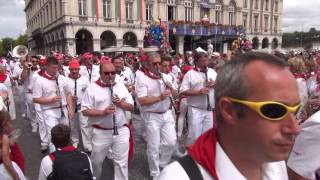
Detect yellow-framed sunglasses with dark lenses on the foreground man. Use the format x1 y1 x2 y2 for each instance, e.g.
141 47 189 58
226 97 301 121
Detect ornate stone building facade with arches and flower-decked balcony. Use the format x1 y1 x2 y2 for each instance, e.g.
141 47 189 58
25 0 283 55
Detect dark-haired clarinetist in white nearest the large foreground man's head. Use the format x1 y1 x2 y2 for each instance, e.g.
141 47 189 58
180 52 217 144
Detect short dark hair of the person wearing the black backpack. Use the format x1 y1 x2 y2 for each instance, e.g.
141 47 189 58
51 124 71 148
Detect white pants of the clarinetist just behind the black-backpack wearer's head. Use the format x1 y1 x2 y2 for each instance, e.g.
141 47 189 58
42 107 69 153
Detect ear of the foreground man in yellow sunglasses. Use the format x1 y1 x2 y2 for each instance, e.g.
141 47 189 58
218 97 238 125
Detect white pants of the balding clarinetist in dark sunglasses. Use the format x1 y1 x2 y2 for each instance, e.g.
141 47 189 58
91 126 130 180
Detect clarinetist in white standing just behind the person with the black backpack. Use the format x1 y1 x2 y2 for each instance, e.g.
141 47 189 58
33 57 74 152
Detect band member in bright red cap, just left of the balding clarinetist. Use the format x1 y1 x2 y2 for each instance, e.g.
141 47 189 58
67 59 92 152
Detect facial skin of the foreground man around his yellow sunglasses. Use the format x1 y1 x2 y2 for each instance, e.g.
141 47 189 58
231 61 300 162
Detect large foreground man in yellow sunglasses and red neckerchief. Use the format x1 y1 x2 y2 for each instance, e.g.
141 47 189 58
160 52 300 180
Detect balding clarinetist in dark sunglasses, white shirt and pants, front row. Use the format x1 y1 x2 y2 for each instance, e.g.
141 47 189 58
81 63 133 180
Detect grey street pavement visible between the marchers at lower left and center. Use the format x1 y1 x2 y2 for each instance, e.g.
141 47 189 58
13 93 150 180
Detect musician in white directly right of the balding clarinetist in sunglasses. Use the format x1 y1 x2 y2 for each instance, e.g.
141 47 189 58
135 53 176 179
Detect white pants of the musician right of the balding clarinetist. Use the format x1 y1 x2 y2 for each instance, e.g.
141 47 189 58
144 110 177 176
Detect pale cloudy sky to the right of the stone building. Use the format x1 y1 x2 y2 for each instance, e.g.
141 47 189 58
282 0 320 32
